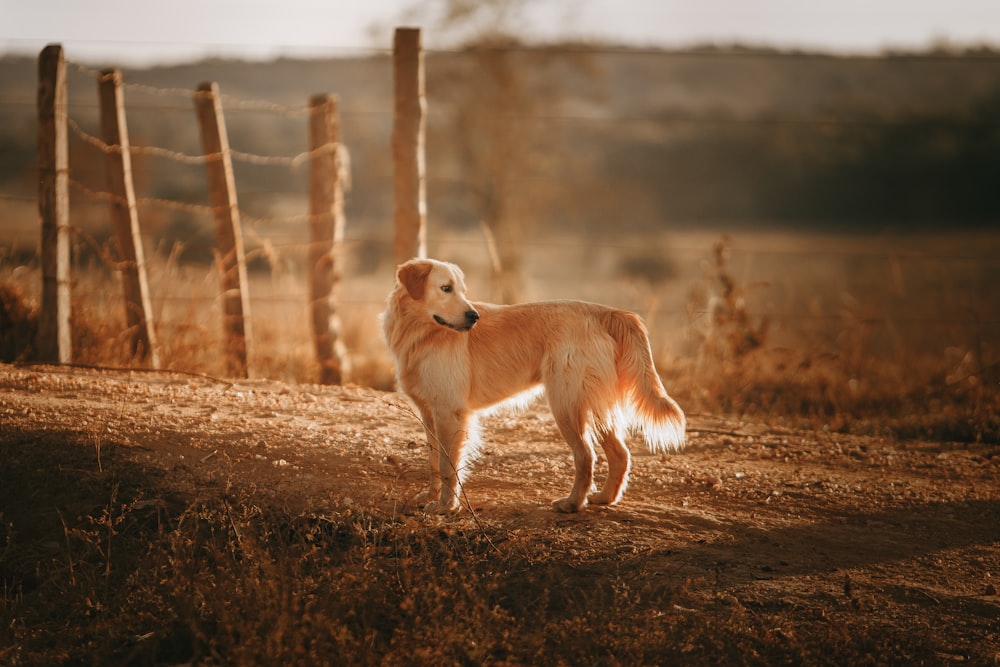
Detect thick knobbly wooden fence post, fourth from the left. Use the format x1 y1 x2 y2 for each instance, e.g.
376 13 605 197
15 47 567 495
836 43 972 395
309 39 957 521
309 95 350 384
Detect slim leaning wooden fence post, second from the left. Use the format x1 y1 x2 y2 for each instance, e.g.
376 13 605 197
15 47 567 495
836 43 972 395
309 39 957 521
97 69 160 368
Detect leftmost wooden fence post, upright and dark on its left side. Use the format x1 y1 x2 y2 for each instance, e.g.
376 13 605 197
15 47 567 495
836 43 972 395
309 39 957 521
37 44 73 364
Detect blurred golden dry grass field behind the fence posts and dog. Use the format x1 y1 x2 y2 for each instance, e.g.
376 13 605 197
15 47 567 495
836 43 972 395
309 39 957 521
0 235 1000 442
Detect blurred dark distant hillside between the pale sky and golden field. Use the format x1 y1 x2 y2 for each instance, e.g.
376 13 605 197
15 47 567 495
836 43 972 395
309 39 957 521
0 46 1000 252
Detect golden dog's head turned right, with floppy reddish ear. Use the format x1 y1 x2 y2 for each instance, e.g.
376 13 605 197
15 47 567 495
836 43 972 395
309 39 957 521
396 259 479 331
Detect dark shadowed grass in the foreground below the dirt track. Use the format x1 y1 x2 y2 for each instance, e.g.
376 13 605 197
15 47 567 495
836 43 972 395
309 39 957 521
0 435 952 665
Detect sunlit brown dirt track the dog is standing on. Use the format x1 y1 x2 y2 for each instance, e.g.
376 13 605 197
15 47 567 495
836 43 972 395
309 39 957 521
0 365 1000 664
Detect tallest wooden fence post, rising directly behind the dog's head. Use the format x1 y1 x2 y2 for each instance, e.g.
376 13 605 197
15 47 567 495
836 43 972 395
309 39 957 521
392 28 427 264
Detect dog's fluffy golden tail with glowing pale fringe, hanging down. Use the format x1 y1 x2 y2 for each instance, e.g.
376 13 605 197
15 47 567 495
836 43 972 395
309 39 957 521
607 311 687 452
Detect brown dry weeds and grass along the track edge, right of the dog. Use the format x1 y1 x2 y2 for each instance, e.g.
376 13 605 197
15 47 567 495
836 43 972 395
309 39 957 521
676 238 1000 442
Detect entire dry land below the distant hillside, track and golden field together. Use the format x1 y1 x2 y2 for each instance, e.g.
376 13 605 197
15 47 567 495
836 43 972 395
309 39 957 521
0 235 1000 665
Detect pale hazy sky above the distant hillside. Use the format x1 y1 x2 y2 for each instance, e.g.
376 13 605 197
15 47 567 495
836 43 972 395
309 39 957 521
0 0 1000 65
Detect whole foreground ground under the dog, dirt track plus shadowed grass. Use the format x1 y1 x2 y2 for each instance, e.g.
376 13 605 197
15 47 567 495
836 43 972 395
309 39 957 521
0 366 1000 665
